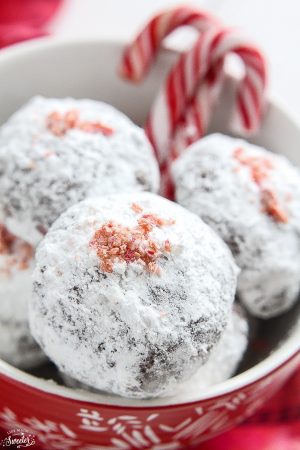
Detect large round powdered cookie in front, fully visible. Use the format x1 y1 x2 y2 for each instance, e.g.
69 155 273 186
29 193 238 398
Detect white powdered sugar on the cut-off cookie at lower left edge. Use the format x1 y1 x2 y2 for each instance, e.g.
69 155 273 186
0 255 46 369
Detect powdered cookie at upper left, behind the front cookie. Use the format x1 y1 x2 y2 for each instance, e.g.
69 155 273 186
0 97 159 245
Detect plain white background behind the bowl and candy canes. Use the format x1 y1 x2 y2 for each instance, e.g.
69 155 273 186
50 0 300 119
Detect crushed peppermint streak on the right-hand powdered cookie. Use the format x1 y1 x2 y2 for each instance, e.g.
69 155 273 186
234 147 288 223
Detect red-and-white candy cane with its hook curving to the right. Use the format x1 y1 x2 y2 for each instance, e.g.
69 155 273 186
146 28 266 163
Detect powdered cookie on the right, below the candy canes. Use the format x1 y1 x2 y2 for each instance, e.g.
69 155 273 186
173 134 300 319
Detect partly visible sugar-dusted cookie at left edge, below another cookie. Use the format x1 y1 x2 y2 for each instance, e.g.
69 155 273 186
0 225 46 369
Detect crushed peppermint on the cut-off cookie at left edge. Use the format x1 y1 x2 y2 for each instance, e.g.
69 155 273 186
0 224 34 273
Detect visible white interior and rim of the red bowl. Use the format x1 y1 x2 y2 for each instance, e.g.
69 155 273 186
0 39 300 405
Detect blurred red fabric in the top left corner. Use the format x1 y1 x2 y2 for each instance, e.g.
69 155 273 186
0 0 61 48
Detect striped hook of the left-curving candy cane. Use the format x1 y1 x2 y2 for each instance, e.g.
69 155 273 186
120 6 219 82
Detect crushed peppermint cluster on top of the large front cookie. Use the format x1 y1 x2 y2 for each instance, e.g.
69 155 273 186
90 207 175 275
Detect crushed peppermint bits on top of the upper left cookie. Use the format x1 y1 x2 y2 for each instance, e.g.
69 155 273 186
46 109 114 137
